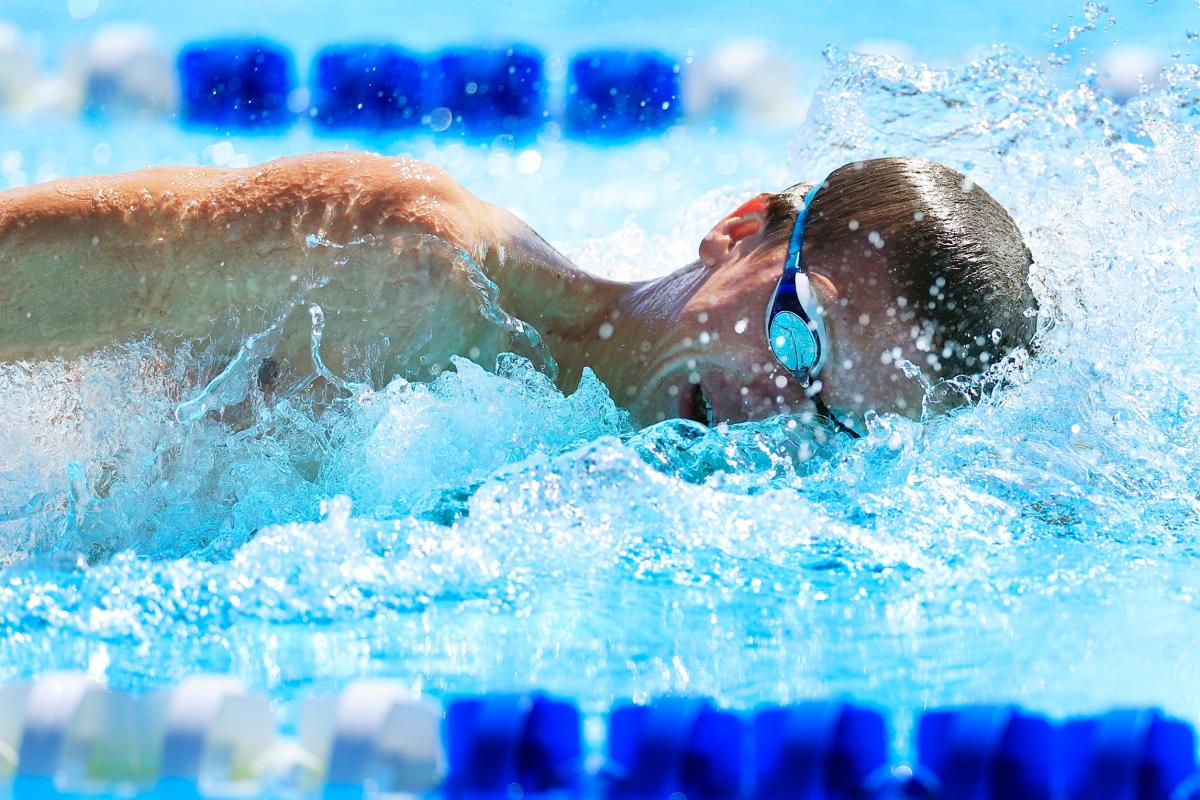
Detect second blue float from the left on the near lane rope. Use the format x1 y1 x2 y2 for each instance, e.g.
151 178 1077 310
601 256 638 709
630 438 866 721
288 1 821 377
607 697 744 800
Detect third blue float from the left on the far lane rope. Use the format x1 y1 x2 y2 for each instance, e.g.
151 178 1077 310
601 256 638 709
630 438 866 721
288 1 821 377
430 46 546 136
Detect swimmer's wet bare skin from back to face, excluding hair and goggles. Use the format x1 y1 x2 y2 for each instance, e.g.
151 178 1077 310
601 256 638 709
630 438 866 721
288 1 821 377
0 154 922 425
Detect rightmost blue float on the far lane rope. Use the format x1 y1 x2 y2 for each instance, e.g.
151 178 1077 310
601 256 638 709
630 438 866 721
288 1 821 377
566 50 680 138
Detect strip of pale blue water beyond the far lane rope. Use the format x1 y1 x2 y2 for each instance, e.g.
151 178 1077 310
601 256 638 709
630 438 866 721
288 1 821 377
7 0 1200 68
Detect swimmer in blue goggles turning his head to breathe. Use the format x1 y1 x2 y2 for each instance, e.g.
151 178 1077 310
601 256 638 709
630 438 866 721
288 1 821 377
0 154 1037 435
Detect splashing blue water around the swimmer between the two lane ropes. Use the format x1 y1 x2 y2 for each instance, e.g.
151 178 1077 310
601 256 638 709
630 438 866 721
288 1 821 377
0 2 1200 743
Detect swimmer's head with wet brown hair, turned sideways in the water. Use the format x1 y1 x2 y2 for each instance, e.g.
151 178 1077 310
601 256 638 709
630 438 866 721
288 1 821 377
633 158 1037 431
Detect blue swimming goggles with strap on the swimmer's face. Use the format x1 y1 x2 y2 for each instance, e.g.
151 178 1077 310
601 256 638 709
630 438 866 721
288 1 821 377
767 184 862 439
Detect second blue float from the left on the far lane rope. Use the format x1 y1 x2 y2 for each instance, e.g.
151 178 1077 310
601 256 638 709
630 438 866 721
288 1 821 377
310 44 428 132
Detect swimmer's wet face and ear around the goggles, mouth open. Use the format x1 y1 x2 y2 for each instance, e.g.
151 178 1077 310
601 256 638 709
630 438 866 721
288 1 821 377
636 197 924 423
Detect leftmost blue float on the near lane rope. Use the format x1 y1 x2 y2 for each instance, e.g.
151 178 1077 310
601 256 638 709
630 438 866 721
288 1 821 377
445 693 583 800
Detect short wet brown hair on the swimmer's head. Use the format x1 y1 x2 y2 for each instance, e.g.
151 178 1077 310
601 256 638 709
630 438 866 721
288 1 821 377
764 158 1037 378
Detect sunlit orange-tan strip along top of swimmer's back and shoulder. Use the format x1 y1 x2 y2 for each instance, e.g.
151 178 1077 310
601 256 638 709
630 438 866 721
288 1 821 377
0 152 498 256
